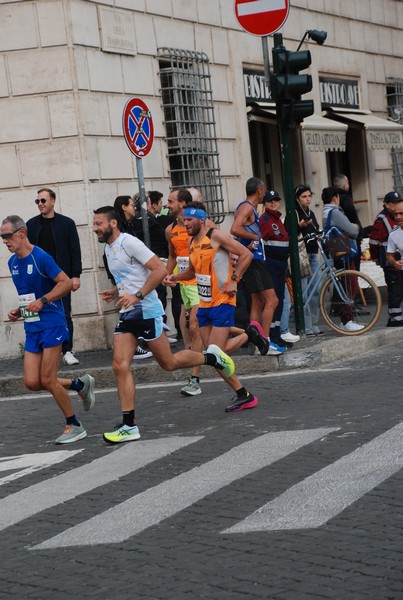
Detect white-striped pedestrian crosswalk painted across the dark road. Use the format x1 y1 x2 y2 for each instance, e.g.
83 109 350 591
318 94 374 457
0 423 403 550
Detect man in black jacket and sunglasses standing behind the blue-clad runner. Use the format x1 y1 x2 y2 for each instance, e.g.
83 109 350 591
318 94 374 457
27 188 82 365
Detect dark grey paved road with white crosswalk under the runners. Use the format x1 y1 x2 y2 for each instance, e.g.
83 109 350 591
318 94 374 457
0 342 403 600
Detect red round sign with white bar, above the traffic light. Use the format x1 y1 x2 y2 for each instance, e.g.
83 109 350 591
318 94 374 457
235 0 290 35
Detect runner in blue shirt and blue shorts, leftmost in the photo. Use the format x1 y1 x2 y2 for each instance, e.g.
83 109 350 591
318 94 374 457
0 215 95 444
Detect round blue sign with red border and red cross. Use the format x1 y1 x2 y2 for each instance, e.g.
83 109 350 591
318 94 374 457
122 98 154 158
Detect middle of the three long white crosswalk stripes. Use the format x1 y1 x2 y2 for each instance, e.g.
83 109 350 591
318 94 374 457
32 428 337 549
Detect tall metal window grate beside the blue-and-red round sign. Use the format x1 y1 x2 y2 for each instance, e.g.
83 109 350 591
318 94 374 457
158 47 224 223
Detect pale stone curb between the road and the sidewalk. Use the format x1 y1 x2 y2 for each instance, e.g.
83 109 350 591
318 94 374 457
0 328 402 398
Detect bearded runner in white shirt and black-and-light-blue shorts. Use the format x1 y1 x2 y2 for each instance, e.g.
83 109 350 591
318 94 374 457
93 206 234 443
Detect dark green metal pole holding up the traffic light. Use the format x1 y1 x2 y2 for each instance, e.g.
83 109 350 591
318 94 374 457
274 33 305 333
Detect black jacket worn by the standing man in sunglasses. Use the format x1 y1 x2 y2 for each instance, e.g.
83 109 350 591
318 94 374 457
27 213 82 277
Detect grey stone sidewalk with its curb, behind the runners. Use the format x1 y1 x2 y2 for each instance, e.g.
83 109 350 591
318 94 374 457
0 304 403 398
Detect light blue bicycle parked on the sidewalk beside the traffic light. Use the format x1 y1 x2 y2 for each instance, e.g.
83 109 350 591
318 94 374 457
302 233 382 335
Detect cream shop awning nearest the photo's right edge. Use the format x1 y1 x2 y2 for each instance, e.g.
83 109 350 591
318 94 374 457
327 109 403 150
